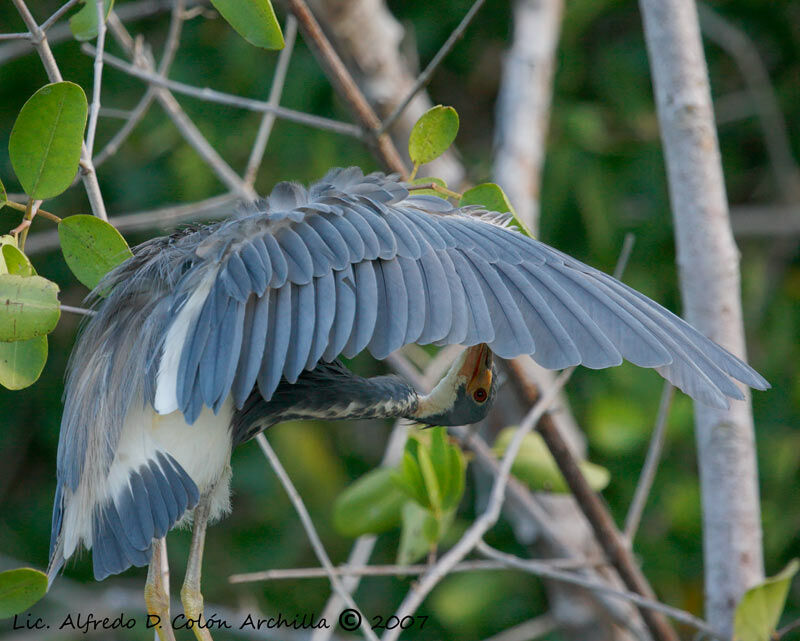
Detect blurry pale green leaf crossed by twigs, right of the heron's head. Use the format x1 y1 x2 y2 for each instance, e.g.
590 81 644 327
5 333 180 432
492 427 611 493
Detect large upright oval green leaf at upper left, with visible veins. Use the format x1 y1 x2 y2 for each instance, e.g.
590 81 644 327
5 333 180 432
8 82 88 200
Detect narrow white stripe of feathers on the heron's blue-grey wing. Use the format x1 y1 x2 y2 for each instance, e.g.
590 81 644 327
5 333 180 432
153 270 217 414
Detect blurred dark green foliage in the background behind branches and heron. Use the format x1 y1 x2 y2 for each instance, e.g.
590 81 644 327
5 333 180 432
0 0 800 640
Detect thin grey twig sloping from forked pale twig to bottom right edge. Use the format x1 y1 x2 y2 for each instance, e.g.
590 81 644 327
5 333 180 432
475 541 730 641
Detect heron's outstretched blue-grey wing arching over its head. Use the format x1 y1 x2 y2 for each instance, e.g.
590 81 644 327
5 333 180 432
150 168 768 422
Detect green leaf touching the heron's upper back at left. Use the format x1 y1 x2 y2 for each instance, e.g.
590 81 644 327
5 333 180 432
58 214 133 289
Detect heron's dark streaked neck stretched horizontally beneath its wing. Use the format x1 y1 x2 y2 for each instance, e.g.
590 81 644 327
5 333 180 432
232 363 420 443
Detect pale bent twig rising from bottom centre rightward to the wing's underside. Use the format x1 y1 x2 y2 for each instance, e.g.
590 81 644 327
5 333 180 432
382 368 574 641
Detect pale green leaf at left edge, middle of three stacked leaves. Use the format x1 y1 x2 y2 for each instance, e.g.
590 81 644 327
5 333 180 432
0 274 61 341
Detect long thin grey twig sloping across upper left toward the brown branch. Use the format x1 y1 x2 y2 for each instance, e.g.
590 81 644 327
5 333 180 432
81 46 364 139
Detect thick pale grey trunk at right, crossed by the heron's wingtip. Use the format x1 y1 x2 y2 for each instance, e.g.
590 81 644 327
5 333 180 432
640 0 764 634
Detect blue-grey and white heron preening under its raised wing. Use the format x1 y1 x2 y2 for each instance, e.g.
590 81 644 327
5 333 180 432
49 168 768 636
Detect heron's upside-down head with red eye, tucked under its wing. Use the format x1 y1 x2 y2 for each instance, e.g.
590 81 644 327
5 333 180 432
411 343 496 425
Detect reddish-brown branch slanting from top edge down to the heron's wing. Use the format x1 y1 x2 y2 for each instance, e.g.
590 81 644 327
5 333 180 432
287 0 408 177
